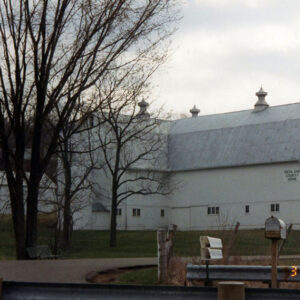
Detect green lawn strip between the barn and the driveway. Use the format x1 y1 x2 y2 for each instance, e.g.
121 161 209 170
0 216 300 260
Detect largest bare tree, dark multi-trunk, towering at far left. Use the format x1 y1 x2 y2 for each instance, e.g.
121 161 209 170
0 0 177 259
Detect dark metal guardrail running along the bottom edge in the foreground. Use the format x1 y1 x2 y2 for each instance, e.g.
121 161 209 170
2 282 300 300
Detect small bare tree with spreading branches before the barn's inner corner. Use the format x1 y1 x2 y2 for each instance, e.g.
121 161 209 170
98 85 172 247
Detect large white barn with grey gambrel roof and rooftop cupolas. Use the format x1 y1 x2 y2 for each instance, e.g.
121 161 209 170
75 89 300 230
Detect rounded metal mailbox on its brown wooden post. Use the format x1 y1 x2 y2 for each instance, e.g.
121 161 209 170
265 216 286 288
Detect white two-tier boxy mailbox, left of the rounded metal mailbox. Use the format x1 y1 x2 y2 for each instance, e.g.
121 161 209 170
200 236 223 260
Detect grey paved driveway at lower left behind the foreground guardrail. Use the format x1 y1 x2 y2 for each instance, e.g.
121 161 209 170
0 257 157 283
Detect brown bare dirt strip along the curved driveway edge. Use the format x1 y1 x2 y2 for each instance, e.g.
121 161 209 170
86 265 156 283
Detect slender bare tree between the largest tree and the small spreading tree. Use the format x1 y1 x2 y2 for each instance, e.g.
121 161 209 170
57 119 99 249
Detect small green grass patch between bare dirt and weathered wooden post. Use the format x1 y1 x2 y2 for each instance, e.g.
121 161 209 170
114 268 158 285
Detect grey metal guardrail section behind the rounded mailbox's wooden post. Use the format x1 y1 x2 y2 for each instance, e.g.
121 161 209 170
186 264 300 282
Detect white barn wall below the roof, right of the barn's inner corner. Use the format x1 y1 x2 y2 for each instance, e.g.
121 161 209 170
170 163 300 230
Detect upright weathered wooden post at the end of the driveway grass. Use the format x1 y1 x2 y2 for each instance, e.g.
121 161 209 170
157 229 168 283
